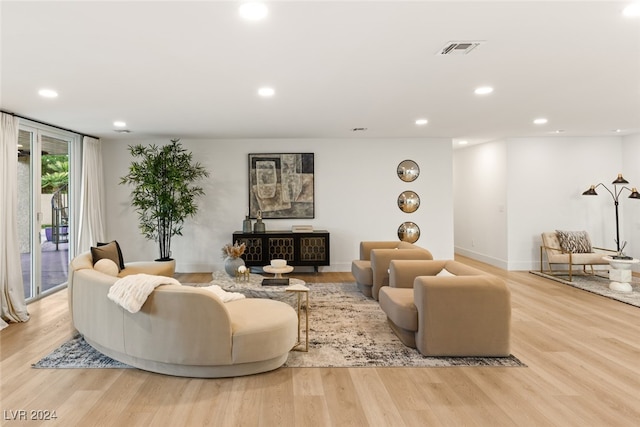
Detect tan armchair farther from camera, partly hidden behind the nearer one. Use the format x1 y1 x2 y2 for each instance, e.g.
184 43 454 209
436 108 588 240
351 241 433 300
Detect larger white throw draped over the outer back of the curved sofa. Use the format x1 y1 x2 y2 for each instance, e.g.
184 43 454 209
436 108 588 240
107 274 181 313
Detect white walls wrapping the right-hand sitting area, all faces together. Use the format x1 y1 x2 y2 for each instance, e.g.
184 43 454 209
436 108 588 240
454 135 640 270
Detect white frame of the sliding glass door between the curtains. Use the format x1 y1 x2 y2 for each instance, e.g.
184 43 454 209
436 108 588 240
19 119 82 303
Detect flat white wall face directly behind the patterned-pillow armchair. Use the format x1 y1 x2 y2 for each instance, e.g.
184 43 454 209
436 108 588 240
507 137 622 270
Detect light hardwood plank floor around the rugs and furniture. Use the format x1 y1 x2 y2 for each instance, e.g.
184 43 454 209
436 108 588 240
0 257 640 427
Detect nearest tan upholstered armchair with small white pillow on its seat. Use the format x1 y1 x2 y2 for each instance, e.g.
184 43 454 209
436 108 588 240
379 260 511 357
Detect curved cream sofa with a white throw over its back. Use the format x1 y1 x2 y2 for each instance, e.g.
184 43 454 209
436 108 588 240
68 252 298 378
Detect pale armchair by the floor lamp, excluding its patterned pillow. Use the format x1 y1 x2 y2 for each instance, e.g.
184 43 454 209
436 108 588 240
540 231 616 282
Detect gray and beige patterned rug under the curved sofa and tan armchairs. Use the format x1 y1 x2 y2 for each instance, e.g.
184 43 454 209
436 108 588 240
33 283 526 368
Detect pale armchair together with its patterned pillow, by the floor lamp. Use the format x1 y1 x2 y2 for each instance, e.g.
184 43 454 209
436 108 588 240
540 231 616 281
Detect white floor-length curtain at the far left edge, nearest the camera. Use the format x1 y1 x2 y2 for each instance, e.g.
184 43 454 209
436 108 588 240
0 113 29 329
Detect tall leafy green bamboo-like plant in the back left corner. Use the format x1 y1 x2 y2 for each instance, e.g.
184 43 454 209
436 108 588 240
120 139 209 261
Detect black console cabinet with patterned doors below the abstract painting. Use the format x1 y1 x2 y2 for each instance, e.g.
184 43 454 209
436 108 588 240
233 230 330 271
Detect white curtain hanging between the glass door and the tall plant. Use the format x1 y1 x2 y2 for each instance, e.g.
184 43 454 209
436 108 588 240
77 136 105 253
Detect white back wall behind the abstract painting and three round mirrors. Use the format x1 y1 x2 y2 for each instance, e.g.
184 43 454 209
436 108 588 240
102 138 454 272
